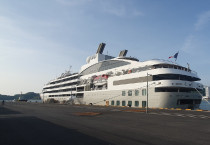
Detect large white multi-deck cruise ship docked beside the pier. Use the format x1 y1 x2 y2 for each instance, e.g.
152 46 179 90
41 43 203 109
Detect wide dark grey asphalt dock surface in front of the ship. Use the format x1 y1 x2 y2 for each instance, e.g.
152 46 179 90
0 103 210 145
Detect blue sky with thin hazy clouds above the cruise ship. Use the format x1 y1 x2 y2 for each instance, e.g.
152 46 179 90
0 0 210 95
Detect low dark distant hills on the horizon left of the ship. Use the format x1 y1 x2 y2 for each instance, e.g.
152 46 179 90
0 92 41 100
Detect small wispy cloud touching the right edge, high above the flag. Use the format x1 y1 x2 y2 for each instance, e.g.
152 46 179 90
195 11 210 31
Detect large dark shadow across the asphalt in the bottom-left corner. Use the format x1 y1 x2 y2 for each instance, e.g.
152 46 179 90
0 115 111 145
